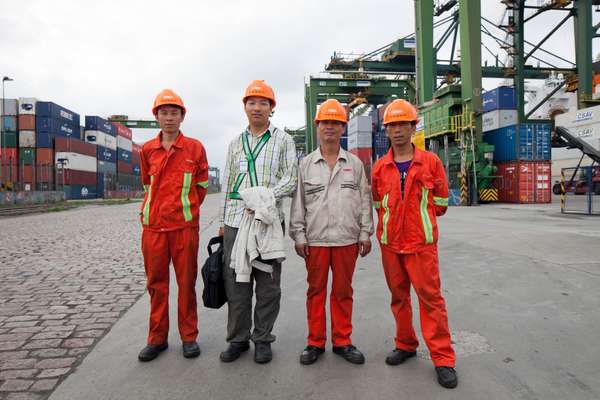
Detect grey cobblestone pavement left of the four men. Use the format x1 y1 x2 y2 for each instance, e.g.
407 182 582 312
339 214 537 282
0 196 216 400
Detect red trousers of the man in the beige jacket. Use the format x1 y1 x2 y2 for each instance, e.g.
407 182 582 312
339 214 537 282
306 244 358 348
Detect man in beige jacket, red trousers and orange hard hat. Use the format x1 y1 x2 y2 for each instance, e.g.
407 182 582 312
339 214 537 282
290 99 373 365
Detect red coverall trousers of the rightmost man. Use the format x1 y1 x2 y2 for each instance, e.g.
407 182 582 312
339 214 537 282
381 246 455 368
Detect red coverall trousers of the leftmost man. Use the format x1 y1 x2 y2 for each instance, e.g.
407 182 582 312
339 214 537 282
142 227 200 344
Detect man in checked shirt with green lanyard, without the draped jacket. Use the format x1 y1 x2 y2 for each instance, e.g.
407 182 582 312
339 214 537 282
219 80 298 363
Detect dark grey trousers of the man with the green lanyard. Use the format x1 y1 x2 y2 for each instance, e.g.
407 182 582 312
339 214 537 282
223 225 281 343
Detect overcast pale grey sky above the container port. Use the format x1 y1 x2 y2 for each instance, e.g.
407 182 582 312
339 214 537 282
0 0 597 167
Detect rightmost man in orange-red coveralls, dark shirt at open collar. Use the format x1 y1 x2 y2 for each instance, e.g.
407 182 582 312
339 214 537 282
372 100 458 388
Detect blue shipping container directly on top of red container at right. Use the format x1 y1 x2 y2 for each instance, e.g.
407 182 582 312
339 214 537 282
483 123 552 162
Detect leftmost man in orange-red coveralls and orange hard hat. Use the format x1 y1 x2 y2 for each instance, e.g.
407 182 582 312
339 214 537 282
138 89 208 361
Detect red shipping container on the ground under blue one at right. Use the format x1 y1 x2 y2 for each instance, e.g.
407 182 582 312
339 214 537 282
496 161 552 203
